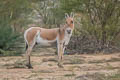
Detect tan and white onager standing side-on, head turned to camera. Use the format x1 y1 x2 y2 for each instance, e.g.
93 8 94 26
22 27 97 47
24 13 74 68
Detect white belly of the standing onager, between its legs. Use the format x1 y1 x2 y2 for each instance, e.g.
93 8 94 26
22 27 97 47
36 36 56 46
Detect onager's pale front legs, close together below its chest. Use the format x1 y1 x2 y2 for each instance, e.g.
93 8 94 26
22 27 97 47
57 42 64 67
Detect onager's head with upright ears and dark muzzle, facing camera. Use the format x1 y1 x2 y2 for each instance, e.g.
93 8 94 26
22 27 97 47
65 13 74 34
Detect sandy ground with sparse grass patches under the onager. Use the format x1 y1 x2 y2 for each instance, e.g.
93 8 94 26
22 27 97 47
0 49 120 80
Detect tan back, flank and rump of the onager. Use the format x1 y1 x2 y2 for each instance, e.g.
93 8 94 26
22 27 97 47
24 27 58 44
